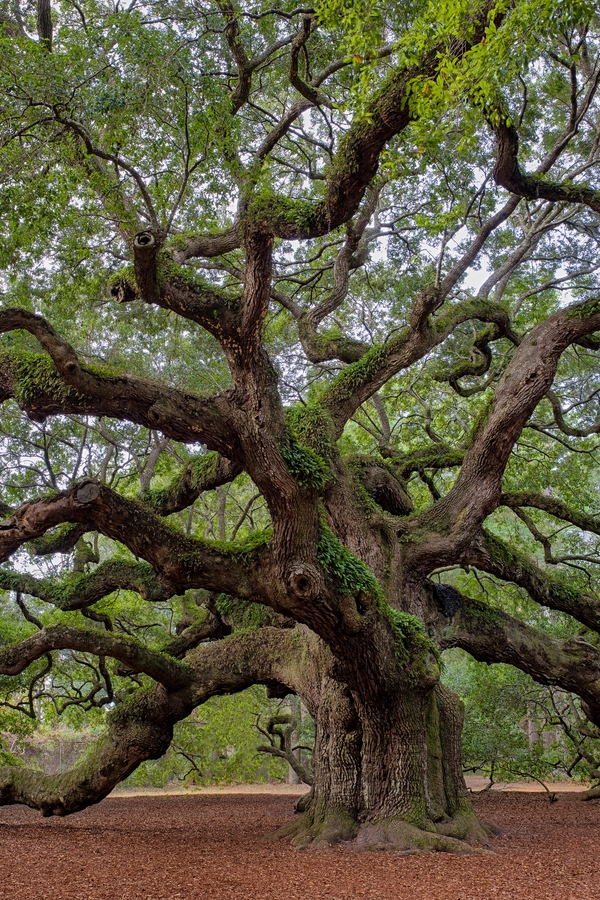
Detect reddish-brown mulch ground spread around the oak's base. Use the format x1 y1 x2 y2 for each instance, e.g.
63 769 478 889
0 792 600 900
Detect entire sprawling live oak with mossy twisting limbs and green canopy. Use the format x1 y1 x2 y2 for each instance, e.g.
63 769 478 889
0 0 600 851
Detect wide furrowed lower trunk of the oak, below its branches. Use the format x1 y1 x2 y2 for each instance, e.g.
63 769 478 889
277 624 488 852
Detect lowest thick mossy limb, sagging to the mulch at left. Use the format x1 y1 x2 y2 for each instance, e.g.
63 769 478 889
0 628 311 816
